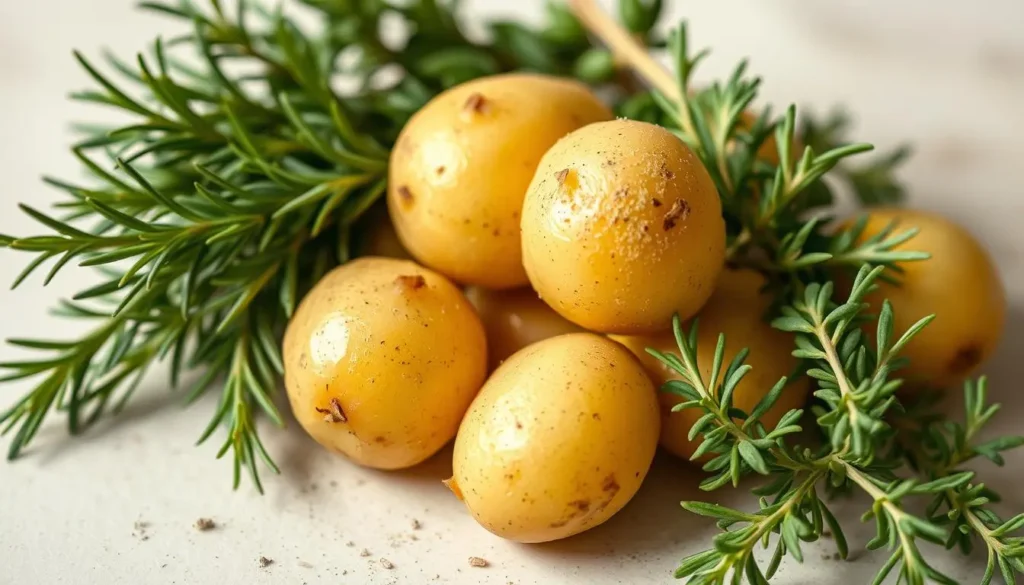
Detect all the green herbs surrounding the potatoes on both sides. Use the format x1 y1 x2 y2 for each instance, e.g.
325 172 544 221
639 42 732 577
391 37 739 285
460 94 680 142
0 0 1024 584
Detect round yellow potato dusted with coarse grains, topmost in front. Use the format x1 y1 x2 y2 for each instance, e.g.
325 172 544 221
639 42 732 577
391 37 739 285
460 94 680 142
522 120 725 334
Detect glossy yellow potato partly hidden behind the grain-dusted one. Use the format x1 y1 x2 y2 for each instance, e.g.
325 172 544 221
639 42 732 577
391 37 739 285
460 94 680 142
387 73 612 289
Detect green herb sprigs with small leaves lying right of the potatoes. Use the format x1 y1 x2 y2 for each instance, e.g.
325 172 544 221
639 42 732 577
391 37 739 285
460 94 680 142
626 20 1024 585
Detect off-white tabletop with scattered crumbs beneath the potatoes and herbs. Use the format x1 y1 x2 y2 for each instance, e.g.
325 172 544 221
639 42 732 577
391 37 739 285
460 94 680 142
0 0 1024 585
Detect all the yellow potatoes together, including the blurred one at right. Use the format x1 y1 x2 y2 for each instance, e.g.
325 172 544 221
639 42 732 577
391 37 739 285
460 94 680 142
284 74 1005 542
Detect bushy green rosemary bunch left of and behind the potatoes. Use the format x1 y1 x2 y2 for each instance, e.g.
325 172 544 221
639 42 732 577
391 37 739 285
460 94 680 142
0 0 660 490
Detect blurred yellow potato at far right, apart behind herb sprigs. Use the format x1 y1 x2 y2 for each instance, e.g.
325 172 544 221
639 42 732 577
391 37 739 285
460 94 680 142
861 209 1007 389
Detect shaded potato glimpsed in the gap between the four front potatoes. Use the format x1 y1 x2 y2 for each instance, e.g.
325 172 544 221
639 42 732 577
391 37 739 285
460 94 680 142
466 287 583 370
